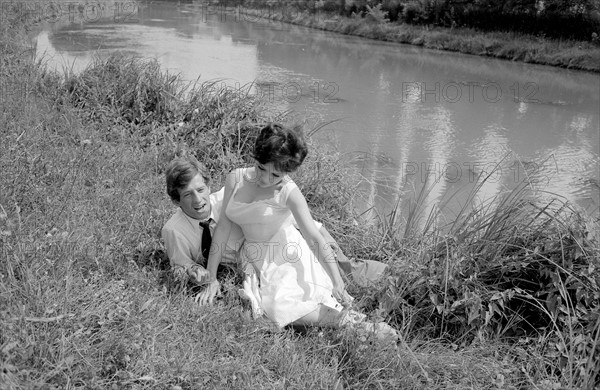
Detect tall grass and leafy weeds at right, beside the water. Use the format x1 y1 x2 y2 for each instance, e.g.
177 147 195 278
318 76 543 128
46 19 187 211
380 167 600 388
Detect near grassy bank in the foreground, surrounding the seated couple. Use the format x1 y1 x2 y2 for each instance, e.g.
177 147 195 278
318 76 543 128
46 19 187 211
0 12 600 390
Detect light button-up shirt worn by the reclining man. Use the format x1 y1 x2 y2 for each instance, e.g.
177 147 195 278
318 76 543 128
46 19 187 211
161 189 243 268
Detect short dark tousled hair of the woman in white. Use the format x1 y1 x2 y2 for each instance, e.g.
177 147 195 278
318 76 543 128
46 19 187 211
254 123 308 172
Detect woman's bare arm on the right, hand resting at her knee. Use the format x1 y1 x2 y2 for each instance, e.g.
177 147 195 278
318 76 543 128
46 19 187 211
287 188 352 304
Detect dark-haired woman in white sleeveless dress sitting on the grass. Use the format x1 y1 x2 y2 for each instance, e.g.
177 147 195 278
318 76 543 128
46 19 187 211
200 124 395 335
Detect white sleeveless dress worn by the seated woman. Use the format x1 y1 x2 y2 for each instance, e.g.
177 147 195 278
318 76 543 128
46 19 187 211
225 170 343 326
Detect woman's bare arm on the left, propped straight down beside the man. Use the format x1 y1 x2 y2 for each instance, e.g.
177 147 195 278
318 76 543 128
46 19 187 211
196 171 236 305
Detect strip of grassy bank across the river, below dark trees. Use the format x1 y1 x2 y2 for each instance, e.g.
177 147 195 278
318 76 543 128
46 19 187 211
232 6 600 72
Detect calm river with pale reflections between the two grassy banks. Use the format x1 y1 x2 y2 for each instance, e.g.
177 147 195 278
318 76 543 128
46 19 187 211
35 2 600 225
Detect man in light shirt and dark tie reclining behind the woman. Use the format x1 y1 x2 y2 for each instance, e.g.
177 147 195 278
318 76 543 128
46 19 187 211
162 157 387 292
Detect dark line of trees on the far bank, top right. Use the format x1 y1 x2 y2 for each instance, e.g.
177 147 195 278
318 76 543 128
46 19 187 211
218 0 600 44
